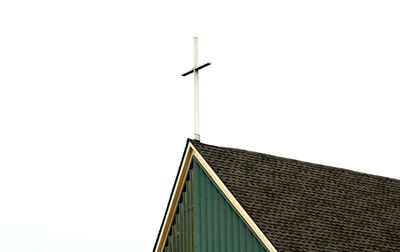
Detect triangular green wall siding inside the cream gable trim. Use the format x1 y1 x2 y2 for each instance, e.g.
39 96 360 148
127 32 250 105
164 158 268 252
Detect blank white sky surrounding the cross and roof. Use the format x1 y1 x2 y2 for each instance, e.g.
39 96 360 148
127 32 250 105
0 0 400 252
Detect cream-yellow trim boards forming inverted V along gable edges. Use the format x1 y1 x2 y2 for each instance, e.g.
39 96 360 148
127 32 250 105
155 142 277 252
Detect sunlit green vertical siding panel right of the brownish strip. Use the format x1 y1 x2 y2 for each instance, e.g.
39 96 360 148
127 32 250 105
192 158 268 252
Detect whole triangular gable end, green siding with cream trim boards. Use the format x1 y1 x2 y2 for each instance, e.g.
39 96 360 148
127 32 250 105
154 141 276 252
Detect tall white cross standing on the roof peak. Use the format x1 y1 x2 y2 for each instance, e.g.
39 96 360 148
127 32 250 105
182 37 211 141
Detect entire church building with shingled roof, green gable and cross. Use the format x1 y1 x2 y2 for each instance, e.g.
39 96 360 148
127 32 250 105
153 37 400 252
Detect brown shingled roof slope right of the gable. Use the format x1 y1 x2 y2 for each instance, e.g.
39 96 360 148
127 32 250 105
189 140 400 252
